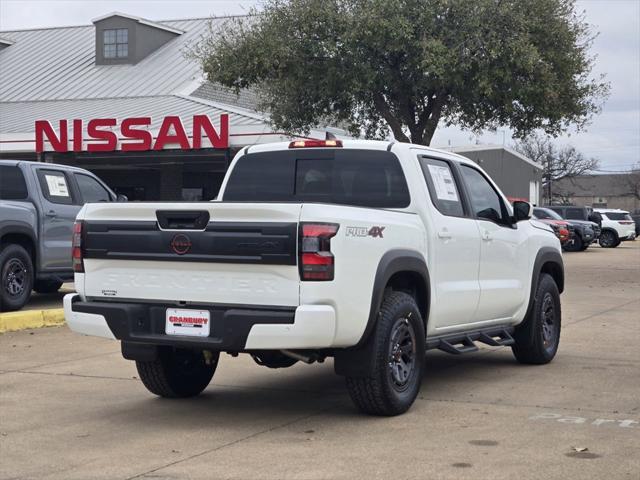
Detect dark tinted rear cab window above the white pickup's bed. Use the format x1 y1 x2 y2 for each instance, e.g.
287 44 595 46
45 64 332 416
222 149 411 208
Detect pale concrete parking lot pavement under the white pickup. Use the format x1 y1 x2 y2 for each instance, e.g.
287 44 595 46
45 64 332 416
0 241 640 480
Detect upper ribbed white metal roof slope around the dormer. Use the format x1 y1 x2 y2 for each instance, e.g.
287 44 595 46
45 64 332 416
0 17 218 102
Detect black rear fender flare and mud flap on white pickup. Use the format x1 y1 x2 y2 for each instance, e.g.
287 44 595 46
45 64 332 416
334 249 431 377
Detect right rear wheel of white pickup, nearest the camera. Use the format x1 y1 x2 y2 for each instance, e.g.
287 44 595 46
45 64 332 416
346 292 425 416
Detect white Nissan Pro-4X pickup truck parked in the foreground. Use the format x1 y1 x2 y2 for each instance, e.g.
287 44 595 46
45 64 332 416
64 140 564 415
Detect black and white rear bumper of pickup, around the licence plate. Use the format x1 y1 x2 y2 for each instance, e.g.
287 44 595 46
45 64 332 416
64 294 336 351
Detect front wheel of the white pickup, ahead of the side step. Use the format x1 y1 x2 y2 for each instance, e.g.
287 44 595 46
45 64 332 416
511 273 562 365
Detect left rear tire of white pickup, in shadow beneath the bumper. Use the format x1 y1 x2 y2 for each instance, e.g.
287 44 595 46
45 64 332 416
136 347 220 398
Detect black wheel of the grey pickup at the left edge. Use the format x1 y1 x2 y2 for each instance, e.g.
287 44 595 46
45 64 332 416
0 245 33 312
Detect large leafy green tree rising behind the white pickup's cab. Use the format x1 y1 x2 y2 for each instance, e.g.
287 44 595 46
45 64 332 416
191 0 608 145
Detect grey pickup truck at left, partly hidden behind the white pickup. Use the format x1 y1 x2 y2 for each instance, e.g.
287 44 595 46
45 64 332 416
0 160 122 311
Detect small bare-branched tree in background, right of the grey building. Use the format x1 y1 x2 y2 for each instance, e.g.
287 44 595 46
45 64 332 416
515 133 599 203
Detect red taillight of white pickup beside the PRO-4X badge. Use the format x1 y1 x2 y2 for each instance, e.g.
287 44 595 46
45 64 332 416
299 223 339 281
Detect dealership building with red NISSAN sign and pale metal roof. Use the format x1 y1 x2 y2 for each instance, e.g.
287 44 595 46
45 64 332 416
0 13 541 203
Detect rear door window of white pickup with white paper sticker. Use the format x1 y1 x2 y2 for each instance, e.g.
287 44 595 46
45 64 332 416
420 157 464 217
